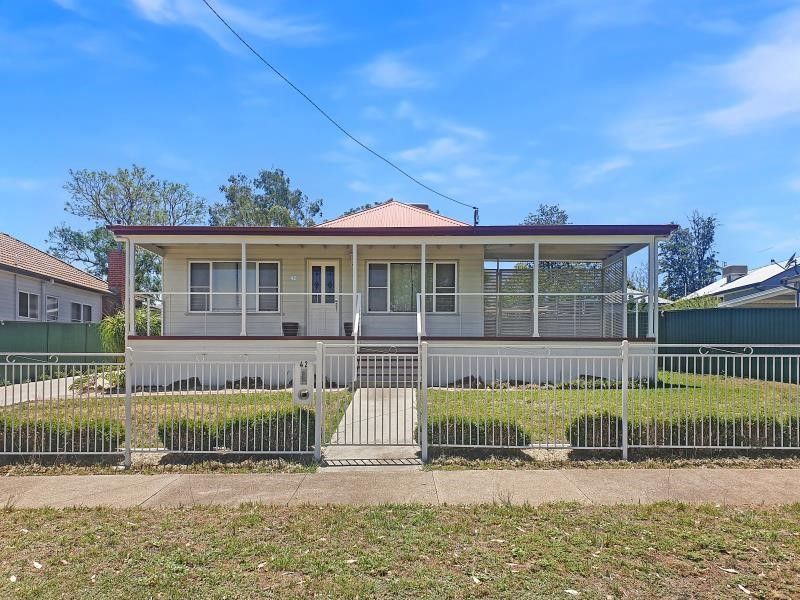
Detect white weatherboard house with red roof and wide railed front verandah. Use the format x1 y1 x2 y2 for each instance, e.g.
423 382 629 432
111 200 674 382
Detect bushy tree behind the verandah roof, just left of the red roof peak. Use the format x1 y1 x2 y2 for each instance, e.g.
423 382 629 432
209 169 322 227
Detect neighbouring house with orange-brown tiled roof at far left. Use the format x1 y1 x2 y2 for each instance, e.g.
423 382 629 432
0 233 113 323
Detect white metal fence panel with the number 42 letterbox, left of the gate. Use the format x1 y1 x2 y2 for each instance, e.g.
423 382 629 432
131 352 316 454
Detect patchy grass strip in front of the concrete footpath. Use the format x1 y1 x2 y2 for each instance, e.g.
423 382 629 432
0 504 800 599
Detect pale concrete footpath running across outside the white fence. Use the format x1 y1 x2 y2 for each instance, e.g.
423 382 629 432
0 468 800 508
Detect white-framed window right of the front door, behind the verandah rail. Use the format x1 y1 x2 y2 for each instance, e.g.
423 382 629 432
367 262 456 313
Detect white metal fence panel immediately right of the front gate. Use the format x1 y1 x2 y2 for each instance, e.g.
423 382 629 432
424 346 623 448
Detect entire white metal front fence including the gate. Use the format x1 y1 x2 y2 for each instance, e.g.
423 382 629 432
0 342 800 464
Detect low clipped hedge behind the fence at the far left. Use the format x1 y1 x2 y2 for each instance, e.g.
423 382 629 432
0 418 125 454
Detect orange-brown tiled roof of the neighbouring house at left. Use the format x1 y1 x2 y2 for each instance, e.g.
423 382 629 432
0 233 109 294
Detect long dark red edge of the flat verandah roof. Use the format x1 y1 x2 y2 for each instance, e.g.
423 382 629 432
109 224 678 237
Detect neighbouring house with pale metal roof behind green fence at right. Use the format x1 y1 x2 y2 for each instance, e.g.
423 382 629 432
686 260 800 308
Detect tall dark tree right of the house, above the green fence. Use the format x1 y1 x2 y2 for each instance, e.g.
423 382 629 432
659 211 720 299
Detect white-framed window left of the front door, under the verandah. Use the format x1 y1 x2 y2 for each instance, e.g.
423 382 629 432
189 261 280 312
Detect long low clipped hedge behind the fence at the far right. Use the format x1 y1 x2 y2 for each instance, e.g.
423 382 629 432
567 413 800 448
